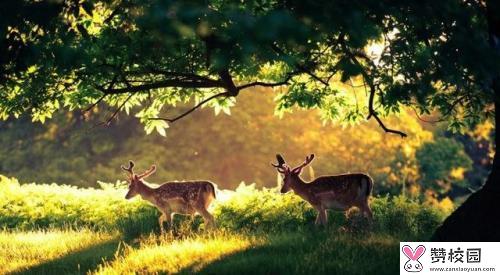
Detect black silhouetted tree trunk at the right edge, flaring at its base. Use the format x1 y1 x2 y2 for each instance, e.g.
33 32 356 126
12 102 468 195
432 0 500 241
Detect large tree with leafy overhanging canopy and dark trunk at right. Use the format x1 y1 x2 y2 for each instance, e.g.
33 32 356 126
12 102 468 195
0 0 500 240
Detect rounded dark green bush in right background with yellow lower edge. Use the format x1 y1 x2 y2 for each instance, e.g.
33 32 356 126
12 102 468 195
416 137 472 193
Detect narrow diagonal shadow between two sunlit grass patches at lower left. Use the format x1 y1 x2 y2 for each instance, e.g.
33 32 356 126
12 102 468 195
10 239 120 275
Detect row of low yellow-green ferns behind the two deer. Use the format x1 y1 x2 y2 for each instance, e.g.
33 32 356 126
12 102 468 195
0 176 448 239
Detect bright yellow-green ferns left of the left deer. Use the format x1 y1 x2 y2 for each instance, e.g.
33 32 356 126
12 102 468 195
0 176 158 235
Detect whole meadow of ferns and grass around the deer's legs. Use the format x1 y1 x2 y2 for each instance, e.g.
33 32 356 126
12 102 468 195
0 176 452 274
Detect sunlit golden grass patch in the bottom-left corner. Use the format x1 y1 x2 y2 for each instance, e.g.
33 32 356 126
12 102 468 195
0 230 117 274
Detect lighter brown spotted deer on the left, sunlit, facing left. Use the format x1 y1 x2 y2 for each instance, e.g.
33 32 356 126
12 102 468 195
121 161 216 234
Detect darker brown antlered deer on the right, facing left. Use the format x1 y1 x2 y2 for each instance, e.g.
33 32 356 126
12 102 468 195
271 154 373 225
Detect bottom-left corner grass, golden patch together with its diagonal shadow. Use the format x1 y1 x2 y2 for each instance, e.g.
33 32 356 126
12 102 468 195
0 230 118 274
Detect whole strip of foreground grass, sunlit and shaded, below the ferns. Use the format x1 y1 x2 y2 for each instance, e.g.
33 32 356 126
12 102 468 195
0 227 399 274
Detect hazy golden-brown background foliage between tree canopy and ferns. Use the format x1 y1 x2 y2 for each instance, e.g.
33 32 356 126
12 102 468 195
0 89 432 191
